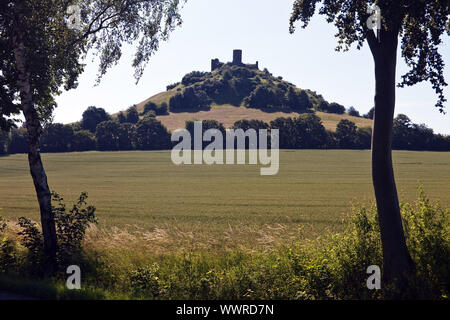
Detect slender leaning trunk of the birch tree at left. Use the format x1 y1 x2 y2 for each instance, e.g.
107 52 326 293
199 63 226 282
13 34 57 272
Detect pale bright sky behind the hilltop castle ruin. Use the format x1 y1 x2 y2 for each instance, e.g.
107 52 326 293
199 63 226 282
54 0 450 134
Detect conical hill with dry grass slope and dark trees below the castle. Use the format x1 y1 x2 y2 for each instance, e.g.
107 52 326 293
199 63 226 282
126 65 372 131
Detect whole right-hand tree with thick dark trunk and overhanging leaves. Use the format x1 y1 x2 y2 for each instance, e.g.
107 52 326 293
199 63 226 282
290 0 450 285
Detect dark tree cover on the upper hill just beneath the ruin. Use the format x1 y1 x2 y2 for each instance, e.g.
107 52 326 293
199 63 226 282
167 65 356 114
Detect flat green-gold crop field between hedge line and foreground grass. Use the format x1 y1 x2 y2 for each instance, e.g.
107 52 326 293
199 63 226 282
0 150 450 248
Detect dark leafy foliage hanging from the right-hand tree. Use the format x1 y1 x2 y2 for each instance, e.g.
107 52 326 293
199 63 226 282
290 0 450 112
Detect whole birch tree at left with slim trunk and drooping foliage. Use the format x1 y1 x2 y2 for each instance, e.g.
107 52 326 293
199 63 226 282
0 0 181 272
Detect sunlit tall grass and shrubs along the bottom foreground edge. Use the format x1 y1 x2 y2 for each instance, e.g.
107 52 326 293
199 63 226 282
0 188 450 299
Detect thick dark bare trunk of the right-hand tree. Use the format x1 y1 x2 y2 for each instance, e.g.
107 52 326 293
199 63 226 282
371 31 414 286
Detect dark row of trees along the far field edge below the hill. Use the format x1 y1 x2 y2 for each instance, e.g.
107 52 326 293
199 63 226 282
0 103 450 154
